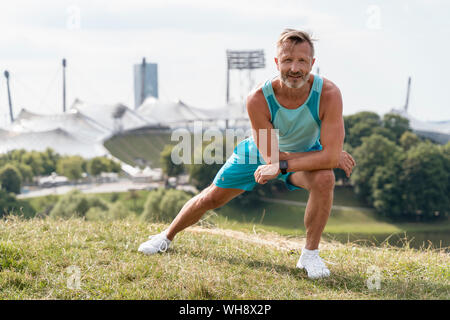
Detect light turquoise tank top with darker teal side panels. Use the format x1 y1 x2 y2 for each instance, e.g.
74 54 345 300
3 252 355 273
262 75 323 152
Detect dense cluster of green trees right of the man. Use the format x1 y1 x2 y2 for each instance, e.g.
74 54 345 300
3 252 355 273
342 112 450 221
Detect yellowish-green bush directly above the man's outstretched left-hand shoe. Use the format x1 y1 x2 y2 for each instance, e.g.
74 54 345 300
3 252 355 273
142 189 190 222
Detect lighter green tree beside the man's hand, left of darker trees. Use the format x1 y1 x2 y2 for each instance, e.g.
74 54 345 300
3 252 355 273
351 134 402 204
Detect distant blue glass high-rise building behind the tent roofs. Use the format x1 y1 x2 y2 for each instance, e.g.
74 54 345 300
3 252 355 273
134 58 158 109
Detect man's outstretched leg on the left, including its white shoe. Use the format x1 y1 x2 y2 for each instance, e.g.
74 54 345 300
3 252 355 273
138 184 244 254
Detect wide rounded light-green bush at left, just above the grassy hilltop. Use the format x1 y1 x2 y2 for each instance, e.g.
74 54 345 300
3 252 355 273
49 190 109 218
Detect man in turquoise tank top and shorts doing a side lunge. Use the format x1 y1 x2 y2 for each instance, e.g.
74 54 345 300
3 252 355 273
138 29 355 279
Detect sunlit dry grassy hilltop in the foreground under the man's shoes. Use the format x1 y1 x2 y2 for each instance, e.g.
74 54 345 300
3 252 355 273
0 216 450 299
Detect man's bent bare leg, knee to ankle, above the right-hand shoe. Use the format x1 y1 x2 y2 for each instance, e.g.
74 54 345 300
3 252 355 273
289 169 335 250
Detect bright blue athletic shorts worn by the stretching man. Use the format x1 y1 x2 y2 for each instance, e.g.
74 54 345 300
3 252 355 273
213 137 301 191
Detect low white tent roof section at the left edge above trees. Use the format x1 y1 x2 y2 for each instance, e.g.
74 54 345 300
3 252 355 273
0 128 108 158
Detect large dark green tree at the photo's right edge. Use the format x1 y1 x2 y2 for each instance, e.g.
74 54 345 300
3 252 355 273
372 142 450 220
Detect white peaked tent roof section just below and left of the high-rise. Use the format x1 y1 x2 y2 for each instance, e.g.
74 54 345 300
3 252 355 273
70 99 156 134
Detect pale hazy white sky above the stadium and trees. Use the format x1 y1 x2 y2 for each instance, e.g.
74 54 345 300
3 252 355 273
0 0 450 127
